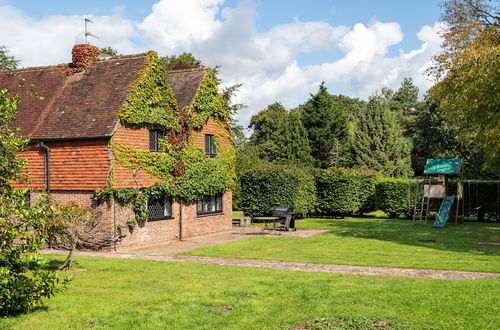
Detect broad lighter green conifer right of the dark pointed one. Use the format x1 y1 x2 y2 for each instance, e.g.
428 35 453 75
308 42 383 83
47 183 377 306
350 95 412 177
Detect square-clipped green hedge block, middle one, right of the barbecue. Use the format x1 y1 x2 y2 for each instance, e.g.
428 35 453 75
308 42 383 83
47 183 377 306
315 168 377 216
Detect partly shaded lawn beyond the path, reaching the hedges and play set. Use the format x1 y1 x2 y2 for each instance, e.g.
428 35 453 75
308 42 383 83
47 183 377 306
186 218 500 272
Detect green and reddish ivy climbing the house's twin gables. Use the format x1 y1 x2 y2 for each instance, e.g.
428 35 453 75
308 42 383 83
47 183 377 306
96 52 236 221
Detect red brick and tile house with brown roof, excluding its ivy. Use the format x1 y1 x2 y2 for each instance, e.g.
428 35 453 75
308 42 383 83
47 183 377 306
0 45 232 250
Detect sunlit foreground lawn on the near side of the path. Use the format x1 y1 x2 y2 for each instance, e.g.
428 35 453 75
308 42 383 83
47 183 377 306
0 256 500 329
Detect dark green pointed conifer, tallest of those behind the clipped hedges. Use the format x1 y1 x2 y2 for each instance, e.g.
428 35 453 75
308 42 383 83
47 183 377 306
301 82 349 168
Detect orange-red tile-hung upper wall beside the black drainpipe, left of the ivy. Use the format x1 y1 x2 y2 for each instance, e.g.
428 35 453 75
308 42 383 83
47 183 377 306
13 139 110 190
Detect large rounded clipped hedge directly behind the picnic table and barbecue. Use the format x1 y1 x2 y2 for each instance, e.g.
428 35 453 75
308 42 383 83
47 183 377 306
240 164 316 216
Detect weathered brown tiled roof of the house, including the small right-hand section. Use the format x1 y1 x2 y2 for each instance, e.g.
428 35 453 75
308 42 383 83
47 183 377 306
0 53 205 140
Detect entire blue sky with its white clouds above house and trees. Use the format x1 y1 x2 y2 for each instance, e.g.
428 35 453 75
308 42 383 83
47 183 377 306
0 0 440 123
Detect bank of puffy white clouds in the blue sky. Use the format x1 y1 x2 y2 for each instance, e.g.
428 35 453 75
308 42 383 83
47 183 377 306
0 0 441 124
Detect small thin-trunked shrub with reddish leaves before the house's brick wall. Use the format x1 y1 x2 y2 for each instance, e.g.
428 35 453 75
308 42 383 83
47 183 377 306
48 201 93 270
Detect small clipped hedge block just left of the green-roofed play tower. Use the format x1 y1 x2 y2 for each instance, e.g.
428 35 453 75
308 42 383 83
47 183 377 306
375 178 415 218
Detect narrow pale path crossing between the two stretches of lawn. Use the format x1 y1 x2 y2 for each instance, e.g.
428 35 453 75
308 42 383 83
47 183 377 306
43 250 500 280
